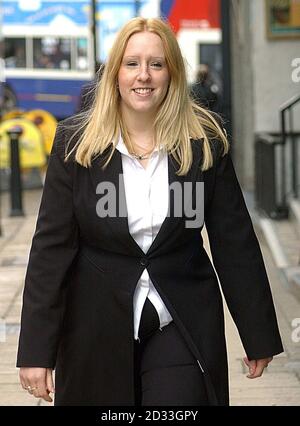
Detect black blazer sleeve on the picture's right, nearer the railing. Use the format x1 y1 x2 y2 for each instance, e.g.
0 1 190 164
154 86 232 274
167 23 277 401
204 146 283 359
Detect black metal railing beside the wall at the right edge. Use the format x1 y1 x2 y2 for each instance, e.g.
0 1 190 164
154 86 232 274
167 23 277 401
255 95 300 219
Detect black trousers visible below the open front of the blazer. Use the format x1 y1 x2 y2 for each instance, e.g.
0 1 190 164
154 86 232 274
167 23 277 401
134 298 208 406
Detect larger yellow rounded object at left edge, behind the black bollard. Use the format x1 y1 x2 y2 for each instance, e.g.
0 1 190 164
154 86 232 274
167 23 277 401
0 118 47 169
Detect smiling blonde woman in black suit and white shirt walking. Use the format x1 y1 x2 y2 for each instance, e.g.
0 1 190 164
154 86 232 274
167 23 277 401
17 18 282 405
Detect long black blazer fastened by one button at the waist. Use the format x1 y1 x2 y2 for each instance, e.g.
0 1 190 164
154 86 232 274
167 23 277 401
17 120 283 405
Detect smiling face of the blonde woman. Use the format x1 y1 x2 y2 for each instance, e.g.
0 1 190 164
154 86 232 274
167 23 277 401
118 31 170 118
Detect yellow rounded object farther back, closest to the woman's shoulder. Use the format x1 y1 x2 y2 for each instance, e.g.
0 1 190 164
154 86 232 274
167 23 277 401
24 109 57 155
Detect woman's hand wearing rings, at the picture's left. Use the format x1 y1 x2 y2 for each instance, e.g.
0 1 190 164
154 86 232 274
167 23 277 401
20 367 54 402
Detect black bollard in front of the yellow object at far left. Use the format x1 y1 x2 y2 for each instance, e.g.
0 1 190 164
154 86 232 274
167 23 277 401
7 126 24 216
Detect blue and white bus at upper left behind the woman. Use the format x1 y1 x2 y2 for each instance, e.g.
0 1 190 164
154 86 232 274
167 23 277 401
1 0 159 119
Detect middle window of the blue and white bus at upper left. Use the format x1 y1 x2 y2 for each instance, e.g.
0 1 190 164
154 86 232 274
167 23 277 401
33 37 71 70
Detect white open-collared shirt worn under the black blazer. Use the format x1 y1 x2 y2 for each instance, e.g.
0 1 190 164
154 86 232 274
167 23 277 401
116 137 172 339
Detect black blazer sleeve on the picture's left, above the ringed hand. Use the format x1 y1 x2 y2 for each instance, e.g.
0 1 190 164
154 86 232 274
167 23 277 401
17 122 78 368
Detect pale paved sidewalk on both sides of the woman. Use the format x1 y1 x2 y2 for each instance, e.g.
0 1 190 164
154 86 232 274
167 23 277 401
0 190 300 406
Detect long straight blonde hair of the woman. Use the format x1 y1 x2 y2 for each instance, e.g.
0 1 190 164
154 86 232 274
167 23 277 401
66 17 228 175
